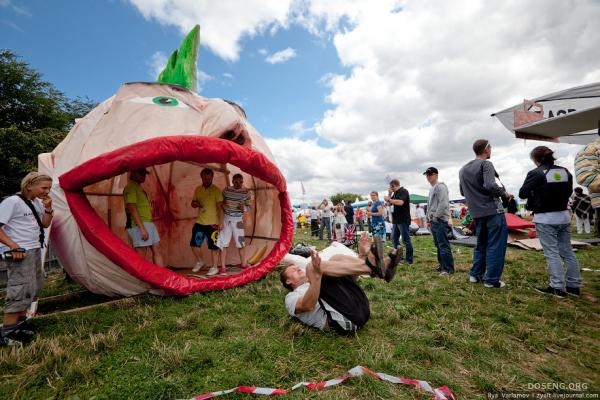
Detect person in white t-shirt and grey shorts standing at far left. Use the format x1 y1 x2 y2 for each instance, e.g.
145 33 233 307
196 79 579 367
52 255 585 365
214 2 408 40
0 172 54 346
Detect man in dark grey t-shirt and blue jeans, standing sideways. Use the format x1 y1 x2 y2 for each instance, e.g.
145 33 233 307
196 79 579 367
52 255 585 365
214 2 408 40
459 139 512 288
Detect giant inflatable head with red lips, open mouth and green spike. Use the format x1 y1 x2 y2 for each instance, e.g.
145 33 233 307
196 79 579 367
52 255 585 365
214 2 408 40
39 26 293 296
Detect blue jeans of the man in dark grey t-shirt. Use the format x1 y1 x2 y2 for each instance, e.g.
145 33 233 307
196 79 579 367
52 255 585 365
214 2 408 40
469 214 508 284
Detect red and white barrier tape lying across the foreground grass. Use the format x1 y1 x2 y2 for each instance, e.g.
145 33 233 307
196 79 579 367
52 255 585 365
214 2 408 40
190 365 455 400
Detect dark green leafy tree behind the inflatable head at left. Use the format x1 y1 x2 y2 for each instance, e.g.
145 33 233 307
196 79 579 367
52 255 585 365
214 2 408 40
0 49 96 197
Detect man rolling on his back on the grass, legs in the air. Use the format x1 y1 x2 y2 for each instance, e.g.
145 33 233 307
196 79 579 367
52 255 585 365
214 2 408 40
280 235 400 335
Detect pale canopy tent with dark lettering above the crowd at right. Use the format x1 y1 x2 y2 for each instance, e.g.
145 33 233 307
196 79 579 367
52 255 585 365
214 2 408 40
492 82 600 144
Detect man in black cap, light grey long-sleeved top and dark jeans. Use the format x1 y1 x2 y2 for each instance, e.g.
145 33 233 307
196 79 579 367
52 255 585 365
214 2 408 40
423 167 454 275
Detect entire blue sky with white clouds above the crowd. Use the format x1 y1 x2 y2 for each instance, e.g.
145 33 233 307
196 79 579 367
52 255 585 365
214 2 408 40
0 0 600 202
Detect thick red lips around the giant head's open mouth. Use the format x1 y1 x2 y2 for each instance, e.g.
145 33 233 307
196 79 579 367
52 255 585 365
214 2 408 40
59 135 293 295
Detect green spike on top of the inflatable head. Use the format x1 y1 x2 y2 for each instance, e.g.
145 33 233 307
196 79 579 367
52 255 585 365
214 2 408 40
156 25 200 92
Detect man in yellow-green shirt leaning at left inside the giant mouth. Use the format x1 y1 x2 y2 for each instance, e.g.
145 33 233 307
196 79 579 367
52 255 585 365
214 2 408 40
123 168 164 265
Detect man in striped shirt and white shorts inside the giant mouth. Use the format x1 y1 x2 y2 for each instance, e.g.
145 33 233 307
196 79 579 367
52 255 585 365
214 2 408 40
217 174 250 273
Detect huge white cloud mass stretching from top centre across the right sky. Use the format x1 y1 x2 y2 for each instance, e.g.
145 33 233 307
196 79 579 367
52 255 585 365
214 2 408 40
127 0 600 203
